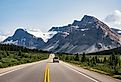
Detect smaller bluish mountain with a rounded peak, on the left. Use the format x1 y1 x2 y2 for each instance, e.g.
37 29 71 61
2 29 45 49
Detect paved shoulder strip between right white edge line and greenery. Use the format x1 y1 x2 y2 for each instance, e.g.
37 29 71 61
61 61 121 82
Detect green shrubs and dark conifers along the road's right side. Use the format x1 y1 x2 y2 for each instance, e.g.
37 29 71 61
57 53 121 79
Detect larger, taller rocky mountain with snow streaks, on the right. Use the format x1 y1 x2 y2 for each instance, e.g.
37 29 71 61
43 15 121 54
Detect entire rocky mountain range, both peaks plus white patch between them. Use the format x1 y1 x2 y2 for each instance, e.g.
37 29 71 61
2 15 121 54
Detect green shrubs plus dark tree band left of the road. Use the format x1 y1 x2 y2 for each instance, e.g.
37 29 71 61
0 44 49 68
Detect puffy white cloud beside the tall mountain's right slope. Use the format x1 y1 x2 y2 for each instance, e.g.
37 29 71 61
104 10 121 29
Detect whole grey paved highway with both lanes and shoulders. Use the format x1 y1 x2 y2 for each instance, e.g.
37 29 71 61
0 54 121 82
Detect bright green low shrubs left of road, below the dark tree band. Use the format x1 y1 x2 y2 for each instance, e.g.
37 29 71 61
0 51 49 68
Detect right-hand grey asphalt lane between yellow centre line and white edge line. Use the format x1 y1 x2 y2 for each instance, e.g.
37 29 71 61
50 63 95 82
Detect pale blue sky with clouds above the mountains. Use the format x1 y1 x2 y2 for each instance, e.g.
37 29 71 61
0 0 121 39
